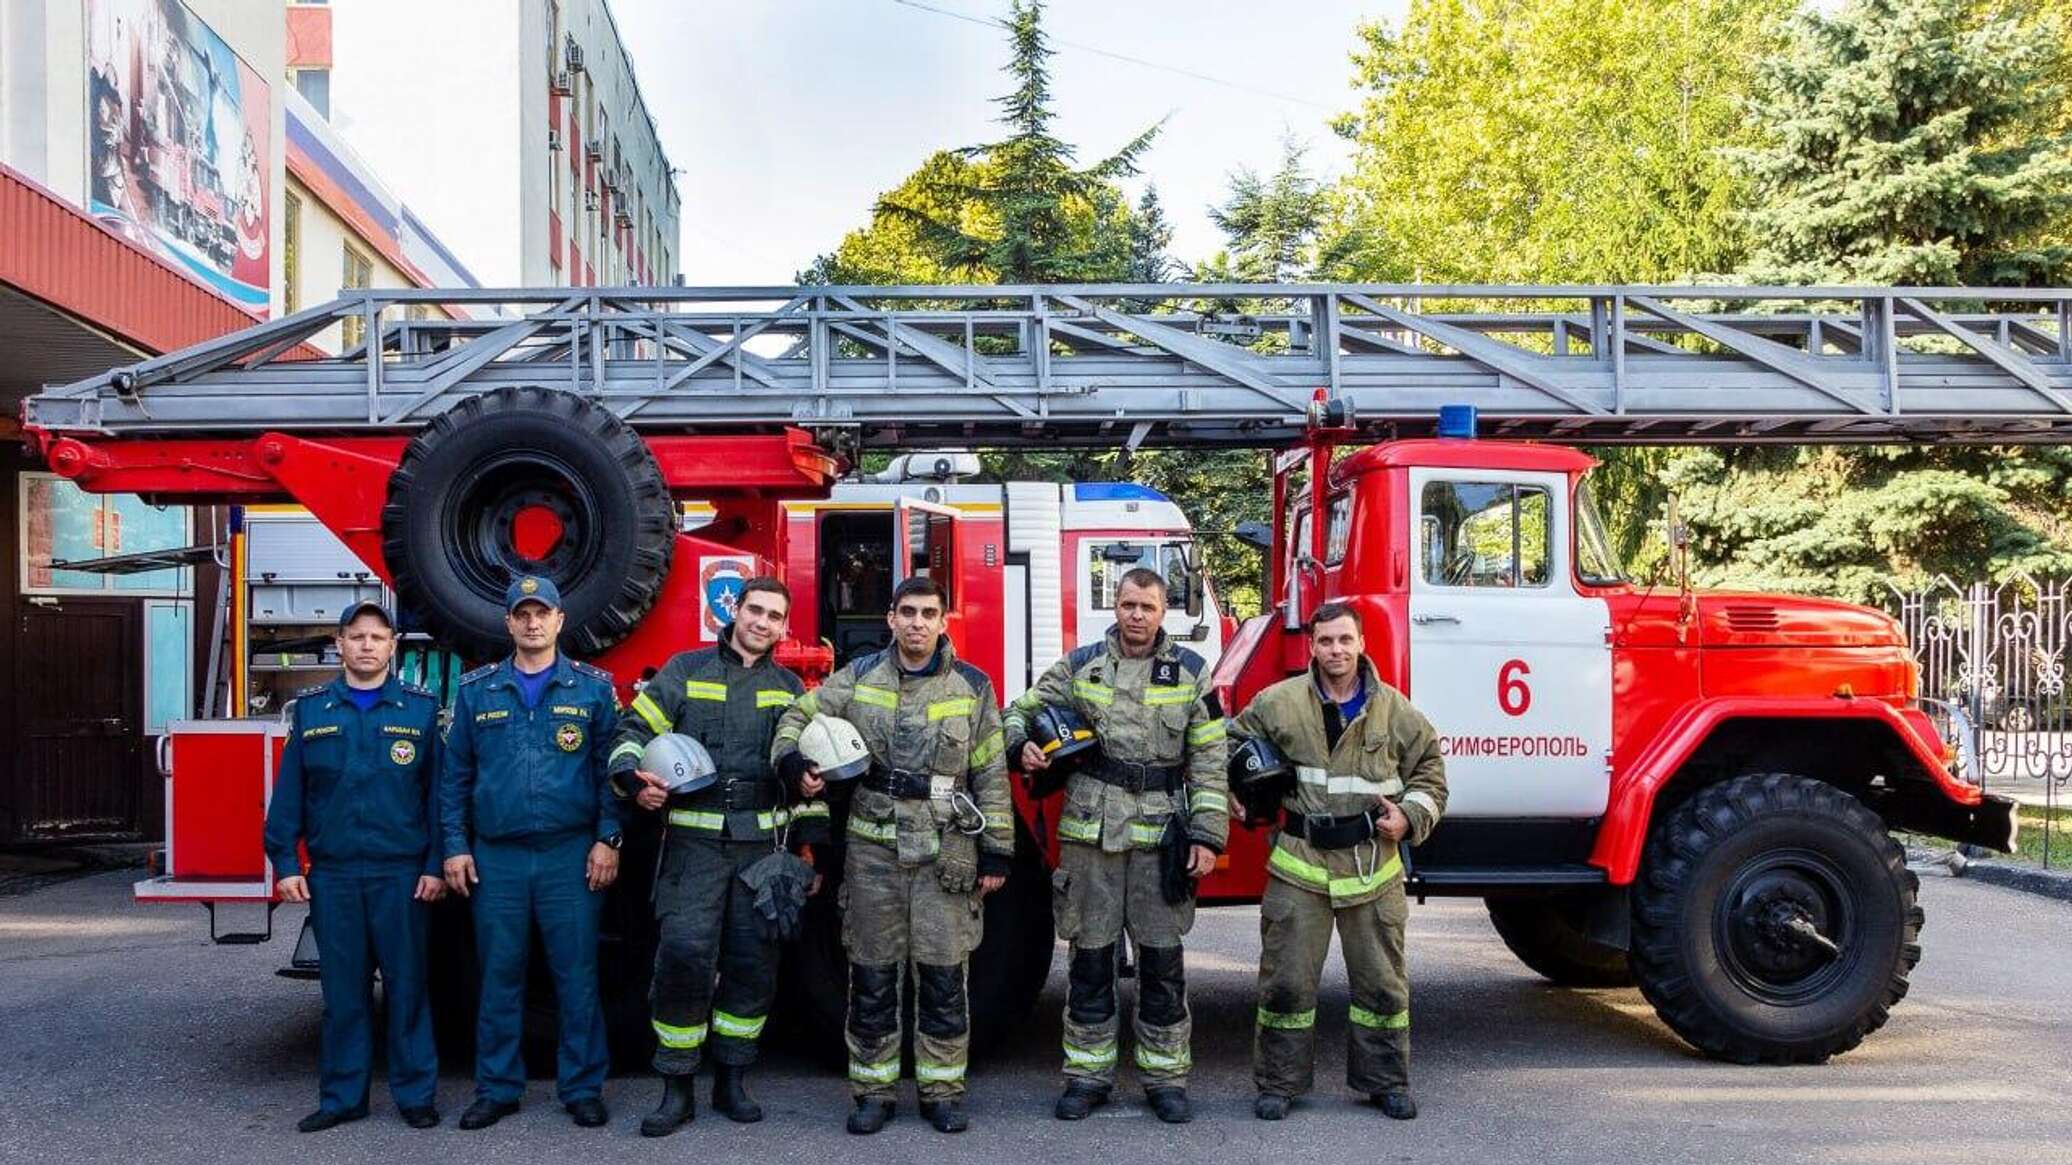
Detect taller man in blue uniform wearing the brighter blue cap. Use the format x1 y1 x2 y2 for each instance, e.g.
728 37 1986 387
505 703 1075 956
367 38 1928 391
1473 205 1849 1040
439 574 622 1130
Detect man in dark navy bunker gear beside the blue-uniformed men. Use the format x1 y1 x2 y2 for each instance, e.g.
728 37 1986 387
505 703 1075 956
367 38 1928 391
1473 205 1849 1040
609 578 827 1136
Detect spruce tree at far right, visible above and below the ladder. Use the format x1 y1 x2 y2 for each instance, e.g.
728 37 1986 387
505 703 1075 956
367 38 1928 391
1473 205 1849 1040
1666 0 2072 601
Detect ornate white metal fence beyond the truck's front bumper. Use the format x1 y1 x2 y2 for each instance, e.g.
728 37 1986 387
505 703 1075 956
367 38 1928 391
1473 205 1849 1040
1890 576 2072 864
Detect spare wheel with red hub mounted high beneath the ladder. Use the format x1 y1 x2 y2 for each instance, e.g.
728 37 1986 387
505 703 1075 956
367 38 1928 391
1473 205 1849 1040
381 388 675 657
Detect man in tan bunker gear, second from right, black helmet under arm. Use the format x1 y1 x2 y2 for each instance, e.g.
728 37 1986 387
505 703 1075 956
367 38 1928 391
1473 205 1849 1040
1007 570 1231 1124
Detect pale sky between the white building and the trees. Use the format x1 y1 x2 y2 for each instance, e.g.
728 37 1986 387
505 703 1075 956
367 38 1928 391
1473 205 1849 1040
592 0 1407 284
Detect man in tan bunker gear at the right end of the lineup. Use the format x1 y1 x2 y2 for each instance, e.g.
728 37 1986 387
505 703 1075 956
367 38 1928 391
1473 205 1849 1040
1231 603 1446 1119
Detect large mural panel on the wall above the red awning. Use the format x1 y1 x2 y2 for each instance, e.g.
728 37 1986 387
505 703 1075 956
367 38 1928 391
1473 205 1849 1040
87 0 274 317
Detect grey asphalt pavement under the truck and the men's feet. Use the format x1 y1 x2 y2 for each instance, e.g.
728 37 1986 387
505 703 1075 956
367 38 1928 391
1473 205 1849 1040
0 873 2072 1165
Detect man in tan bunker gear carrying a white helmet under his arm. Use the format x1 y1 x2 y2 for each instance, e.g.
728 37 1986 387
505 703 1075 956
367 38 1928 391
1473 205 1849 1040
775 576 1015 1134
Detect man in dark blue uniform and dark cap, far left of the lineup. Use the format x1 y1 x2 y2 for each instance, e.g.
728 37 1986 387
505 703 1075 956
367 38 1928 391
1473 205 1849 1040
265 603 445 1132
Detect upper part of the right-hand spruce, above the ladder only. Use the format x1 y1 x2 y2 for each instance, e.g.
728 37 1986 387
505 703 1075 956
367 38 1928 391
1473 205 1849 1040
1734 0 2072 286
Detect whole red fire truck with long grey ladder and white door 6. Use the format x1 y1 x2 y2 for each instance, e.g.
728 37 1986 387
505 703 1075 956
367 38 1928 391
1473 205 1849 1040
27 286 2038 1061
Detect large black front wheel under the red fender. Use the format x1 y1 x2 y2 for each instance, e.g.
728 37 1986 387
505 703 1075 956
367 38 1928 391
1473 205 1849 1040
1633 773 1923 1063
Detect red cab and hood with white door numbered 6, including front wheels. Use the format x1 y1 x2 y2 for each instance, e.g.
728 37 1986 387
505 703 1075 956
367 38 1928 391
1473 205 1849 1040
1214 433 2014 1061
